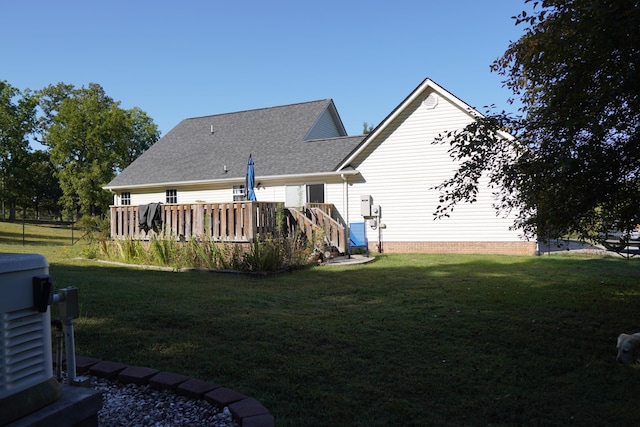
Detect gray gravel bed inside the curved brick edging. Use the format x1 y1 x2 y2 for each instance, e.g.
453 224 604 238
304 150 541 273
89 376 238 427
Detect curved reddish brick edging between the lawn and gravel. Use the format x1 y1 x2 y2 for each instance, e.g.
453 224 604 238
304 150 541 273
76 356 275 427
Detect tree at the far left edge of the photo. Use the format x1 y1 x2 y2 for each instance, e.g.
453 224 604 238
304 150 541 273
0 81 37 219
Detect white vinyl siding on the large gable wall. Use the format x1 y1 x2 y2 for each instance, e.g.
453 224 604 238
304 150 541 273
349 89 519 242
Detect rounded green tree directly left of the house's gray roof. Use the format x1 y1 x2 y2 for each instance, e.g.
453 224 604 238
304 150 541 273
39 83 159 215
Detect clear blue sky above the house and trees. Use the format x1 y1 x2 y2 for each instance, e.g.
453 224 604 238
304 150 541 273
0 0 525 140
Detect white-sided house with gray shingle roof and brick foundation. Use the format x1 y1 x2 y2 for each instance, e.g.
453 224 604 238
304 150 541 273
105 79 536 254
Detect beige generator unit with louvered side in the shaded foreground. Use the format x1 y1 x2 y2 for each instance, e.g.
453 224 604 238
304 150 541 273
0 253 61 425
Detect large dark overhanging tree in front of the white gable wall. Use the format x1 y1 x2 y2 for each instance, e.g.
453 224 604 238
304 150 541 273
435 0 640 238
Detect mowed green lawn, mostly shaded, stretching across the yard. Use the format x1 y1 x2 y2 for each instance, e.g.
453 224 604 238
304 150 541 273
0 223 640 426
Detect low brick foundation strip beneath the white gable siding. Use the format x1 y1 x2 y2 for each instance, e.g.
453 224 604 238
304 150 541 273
369 241 536 255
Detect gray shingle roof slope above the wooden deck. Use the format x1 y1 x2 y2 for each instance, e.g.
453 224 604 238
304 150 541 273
107 99 364 187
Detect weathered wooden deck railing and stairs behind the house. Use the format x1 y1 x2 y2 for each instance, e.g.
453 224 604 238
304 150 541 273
111 201 346 253
